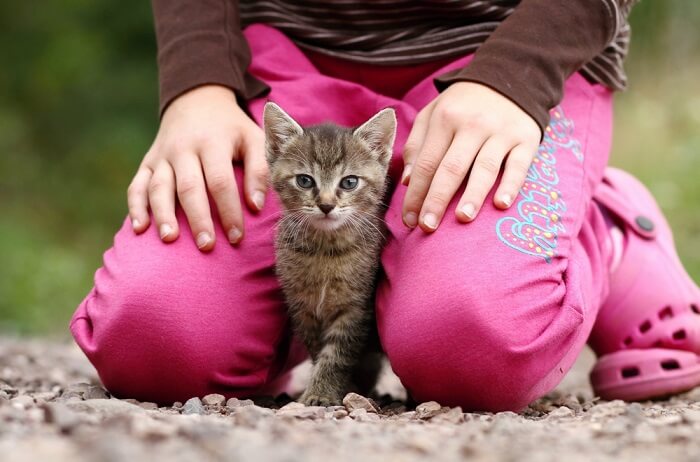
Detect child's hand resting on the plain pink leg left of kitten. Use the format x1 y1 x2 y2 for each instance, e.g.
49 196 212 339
127 85 267 250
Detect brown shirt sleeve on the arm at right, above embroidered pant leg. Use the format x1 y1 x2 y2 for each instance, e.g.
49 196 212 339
435 0 625 133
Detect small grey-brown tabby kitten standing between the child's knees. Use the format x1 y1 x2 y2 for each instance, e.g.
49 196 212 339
263 103 396 406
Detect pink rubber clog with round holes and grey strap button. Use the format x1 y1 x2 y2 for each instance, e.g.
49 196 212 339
589 168 700 401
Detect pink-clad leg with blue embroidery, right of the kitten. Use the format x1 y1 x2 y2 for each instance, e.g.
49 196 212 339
377 61 611 410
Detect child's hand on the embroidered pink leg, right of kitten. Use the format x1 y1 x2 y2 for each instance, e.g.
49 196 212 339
402 82 541 232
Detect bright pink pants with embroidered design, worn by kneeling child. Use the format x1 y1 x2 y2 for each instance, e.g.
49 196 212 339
71 25 611 410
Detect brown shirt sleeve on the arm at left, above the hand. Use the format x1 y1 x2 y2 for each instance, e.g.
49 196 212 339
152 0 269 116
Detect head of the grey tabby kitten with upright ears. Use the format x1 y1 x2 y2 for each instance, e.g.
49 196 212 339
263 103 396 231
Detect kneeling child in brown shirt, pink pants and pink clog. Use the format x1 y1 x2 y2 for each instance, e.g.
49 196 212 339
71 0 700 410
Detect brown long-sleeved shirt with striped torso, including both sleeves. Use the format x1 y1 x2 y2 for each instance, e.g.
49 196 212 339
152 0 634 128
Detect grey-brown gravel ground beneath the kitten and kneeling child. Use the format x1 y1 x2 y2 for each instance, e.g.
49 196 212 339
0 337 700 462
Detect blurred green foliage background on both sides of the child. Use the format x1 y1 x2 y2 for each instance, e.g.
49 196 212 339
0 0 700 335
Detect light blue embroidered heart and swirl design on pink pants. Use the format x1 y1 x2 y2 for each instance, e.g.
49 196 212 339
496 106 583 263
